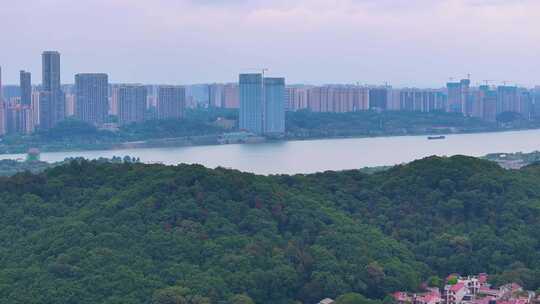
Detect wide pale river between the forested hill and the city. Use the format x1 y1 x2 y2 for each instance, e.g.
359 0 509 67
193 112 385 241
0 130 540 174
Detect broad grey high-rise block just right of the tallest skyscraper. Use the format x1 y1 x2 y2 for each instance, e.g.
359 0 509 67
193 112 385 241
75 74 109 125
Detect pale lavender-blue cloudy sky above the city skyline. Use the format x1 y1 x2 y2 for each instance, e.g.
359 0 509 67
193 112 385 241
0 0 540 87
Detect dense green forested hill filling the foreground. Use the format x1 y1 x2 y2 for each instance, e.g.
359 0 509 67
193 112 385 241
0 157 540 304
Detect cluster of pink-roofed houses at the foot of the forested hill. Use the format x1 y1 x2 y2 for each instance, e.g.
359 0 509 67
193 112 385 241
393 273 536 304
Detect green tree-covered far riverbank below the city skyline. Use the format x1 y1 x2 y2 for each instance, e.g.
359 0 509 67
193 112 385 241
0 109 540 154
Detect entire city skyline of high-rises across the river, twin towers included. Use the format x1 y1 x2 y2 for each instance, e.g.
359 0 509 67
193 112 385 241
0 51 540 136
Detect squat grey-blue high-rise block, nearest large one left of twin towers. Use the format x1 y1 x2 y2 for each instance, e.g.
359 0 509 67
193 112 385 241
157 86 186 119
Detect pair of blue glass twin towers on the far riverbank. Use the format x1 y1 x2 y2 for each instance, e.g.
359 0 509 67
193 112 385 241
239 74 285 134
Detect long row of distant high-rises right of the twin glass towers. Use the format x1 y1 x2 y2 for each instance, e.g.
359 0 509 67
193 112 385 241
286 79 540 121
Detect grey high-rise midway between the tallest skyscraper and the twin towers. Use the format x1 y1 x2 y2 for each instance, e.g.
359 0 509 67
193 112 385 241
117 85 148 125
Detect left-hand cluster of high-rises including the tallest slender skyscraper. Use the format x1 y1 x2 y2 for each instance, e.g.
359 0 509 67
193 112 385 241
0 51 186 136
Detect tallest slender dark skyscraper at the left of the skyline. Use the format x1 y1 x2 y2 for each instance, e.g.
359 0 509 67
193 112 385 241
39 51 65 129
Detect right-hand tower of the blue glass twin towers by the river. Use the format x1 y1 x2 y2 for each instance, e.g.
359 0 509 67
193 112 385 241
263 78 285 134
